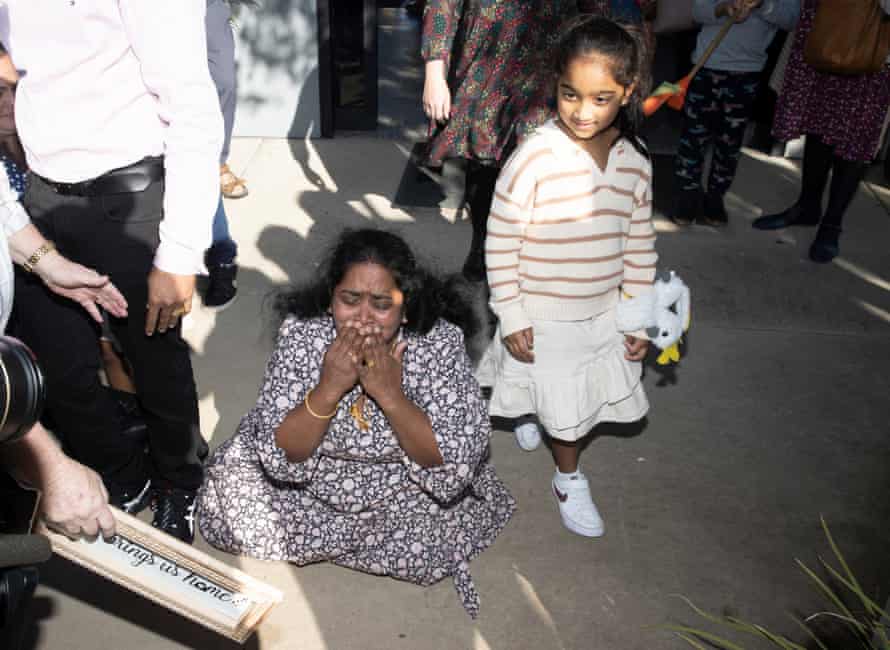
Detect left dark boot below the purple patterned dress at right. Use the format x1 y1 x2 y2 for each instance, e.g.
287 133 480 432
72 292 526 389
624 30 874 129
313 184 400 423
751 133 834 230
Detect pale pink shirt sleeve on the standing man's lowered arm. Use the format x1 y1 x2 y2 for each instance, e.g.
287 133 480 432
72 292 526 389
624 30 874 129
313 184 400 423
120 0 223 275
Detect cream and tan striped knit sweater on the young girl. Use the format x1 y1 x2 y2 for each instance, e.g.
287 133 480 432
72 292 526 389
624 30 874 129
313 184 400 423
485 120 658 336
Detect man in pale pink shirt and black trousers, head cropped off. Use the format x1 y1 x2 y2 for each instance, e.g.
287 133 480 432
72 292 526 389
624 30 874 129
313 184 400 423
0 0 223 542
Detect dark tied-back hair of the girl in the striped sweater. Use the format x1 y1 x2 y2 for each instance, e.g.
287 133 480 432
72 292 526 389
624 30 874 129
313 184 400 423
553 14 652 156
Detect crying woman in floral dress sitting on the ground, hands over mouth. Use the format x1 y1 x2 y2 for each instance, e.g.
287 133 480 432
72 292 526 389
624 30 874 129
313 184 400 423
198 230 515 616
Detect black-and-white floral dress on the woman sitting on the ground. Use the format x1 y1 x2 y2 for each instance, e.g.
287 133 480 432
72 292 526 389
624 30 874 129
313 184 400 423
198 317 515 617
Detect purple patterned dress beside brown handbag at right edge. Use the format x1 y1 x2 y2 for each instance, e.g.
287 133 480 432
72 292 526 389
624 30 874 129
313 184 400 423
773 0 890 162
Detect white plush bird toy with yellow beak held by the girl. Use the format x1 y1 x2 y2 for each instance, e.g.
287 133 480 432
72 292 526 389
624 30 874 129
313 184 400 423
615 271 692 366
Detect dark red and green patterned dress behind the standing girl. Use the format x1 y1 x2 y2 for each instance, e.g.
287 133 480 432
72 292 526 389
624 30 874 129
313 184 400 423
421 0 578 165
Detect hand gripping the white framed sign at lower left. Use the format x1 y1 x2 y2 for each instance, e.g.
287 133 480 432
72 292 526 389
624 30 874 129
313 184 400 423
41 456 114 539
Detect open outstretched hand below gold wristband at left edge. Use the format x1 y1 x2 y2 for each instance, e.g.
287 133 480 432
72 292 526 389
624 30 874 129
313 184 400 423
34 251 127 323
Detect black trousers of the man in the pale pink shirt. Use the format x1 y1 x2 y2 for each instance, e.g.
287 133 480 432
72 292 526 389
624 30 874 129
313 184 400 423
13 174 207 489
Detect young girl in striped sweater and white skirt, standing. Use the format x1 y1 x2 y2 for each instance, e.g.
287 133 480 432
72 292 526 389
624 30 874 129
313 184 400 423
479 16 657 537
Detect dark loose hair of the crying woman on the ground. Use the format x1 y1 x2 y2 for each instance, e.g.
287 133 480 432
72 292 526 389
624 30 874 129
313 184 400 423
275 228 482 338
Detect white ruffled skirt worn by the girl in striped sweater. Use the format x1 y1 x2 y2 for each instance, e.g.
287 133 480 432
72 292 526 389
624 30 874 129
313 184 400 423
476 309 649 441
